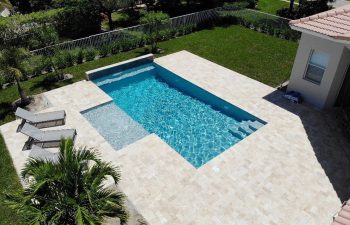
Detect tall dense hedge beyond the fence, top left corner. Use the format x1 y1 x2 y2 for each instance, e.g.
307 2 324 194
0 7 101 50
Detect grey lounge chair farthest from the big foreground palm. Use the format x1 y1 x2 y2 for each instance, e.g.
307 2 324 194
15 107 66 132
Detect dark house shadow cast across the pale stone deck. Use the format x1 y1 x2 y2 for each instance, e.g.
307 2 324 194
264 91 350 202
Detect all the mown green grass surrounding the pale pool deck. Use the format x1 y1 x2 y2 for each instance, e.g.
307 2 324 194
0 26 297 225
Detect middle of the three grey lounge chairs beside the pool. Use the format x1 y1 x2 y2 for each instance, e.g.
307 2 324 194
20 123 77 150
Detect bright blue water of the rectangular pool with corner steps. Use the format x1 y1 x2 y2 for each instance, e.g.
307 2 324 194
89 63 265 168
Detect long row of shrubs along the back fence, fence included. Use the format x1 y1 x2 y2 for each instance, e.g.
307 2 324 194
0 7 300 85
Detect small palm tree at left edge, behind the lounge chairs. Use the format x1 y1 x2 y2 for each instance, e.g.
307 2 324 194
0 47 29 105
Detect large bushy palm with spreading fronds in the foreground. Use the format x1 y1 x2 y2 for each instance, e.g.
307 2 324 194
6 140 128 225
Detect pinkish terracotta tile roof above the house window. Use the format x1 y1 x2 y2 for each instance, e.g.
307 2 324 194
289 4 350 41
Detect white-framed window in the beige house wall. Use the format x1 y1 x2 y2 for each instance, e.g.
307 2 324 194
305 50 329 84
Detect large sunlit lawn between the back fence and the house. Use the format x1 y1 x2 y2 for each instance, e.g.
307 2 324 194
159 26 298 87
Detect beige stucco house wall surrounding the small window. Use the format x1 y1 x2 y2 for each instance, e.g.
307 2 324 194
288 33 350 108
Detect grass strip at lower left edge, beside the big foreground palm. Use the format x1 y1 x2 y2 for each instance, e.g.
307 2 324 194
0 134 24 225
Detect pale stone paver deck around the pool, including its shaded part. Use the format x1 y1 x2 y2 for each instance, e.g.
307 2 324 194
0 51 350 225
